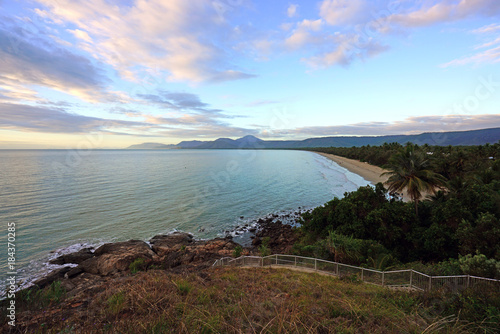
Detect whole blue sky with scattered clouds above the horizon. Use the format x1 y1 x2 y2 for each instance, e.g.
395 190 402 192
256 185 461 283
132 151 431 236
0 0 500 149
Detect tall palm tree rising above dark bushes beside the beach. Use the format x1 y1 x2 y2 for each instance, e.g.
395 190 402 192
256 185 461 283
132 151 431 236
382 143 446 217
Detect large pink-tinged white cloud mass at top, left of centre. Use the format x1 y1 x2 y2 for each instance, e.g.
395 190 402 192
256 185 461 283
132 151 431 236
33 0 254 82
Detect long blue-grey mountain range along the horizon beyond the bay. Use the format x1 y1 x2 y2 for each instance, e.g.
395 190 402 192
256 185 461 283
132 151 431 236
128 128 500 149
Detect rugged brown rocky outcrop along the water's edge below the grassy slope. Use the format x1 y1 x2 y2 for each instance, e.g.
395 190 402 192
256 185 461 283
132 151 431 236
28 219 296 295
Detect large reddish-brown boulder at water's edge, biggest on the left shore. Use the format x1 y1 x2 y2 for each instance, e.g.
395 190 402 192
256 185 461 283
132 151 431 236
78 240 156 276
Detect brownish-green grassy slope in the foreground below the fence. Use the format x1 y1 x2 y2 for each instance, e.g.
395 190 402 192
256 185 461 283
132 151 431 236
1 267 498 333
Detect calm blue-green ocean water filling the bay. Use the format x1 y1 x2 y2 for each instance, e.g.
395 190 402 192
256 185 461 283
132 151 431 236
0 150 368 290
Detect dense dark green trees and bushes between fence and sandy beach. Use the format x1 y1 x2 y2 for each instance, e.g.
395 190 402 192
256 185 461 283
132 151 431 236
300 143 500 278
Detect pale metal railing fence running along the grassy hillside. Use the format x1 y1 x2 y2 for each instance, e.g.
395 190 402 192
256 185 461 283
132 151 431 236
213 254 500 292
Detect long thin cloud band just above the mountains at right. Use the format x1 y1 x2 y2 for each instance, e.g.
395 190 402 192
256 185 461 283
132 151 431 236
288 114 500 137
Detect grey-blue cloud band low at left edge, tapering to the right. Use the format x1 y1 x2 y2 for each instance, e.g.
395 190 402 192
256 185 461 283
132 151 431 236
0 103 150 133
